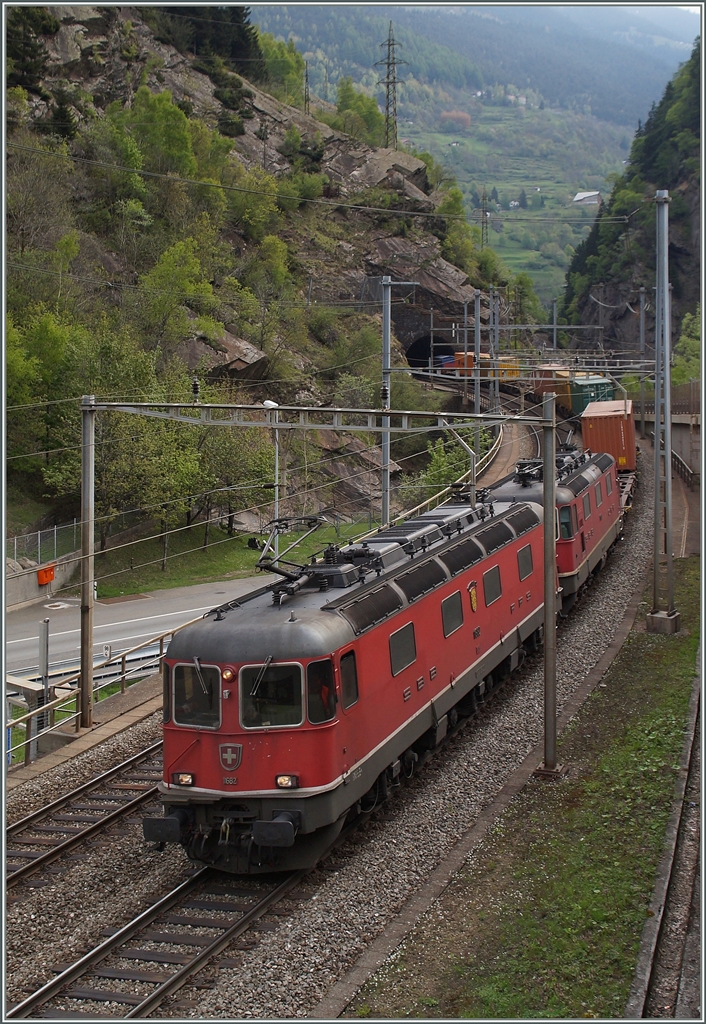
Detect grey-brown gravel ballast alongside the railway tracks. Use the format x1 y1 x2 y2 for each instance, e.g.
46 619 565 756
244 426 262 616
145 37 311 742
7 453 652 1020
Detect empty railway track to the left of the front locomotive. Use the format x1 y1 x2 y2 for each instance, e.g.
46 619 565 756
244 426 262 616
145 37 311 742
5 741 162 889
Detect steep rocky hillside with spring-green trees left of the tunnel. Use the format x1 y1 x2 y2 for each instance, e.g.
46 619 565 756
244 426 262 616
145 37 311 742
6 7 512 543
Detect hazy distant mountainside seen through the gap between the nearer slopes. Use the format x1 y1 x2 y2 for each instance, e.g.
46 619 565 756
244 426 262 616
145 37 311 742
248 5 698 305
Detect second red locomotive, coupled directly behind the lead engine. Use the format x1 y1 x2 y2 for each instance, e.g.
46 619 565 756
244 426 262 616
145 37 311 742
491 449 623 614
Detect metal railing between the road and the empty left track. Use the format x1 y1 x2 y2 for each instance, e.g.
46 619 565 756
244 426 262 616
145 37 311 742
5 616 201 765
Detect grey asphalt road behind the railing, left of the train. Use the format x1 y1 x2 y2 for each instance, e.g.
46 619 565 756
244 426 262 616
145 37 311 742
5 573 274 676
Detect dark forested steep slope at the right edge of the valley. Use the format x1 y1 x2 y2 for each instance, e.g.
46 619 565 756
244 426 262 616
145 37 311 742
564 40 702 352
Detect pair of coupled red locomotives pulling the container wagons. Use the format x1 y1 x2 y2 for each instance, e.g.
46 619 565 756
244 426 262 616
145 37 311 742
143 452 622 874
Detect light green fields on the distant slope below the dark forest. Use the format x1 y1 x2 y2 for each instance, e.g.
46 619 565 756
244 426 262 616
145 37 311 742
400 103 629 306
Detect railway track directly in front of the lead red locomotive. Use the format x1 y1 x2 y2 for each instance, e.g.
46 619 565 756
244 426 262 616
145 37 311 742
6 867 308 1020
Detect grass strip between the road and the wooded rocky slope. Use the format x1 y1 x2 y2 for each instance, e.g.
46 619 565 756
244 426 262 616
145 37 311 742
55 521 377 598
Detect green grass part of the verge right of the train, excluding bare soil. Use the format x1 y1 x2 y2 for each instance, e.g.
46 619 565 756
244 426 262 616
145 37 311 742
450 559 699 1018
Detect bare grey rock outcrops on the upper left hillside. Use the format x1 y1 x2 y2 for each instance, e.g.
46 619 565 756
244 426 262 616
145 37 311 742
31 6 483 335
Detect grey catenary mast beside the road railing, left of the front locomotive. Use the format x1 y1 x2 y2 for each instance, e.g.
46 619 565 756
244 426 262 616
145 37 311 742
80 394 95 729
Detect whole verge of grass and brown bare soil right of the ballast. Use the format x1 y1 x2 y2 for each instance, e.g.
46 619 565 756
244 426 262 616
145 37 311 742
345 558 700 1019
